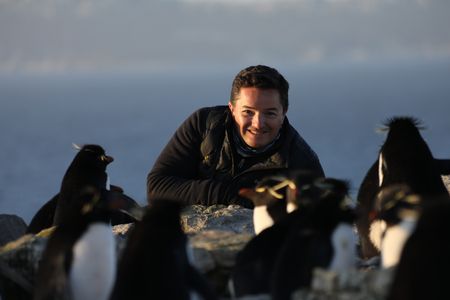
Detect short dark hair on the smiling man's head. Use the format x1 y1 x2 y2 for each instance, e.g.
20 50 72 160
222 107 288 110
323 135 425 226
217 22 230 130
230 65 289 112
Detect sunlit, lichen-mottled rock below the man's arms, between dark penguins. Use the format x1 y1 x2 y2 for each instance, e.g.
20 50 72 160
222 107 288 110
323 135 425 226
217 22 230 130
181 205 254 296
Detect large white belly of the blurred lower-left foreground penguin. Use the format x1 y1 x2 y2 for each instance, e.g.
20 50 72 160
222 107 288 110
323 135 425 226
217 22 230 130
69 222 116 300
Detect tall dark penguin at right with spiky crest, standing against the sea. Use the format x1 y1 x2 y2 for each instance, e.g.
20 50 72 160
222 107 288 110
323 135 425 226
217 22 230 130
356 117 448 258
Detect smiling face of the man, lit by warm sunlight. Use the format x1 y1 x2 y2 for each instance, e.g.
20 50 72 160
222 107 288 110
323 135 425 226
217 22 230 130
228 87 286 148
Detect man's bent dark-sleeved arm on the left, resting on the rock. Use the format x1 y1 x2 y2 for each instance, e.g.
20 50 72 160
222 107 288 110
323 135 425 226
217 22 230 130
147 109 229 205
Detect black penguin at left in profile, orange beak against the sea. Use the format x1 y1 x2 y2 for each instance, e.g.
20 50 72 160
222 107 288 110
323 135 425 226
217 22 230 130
27 145 140 233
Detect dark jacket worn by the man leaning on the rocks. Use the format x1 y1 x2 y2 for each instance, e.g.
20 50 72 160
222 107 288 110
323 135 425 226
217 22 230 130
147 106 323 205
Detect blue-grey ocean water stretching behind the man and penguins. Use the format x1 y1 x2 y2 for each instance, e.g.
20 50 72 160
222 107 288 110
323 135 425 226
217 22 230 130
0 62 450 222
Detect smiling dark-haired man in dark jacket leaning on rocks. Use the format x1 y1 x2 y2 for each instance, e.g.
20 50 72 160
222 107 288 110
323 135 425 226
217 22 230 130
147 65 324 207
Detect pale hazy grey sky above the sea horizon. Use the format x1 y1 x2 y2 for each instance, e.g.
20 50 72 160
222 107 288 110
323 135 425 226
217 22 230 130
0 0 450 74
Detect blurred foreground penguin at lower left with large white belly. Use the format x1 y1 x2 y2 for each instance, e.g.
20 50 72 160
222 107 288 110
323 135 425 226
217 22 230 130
33 187 120 300
